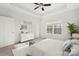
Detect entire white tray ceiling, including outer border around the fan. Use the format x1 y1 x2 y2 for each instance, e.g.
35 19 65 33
0 3 79 17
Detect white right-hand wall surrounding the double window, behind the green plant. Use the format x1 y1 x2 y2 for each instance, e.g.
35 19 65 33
41 9 79 40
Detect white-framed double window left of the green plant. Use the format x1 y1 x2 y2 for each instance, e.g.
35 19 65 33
47 23 62 34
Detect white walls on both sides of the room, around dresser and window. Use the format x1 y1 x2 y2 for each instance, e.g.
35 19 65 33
0 4 79 47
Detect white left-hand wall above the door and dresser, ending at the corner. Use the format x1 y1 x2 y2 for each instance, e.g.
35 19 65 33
0 4 40 47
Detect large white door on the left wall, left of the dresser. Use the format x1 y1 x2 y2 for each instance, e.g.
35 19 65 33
0 17 15 47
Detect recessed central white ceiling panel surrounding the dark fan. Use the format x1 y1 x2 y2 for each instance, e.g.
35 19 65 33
10 3 67 16
